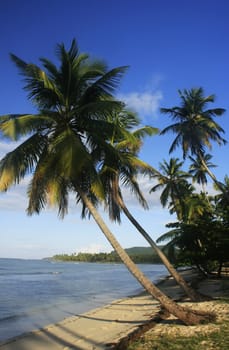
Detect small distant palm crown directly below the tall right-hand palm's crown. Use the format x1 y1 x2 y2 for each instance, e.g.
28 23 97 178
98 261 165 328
189 153 216 192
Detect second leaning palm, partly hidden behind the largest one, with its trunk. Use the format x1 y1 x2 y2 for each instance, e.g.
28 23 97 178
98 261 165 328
100 114 202 300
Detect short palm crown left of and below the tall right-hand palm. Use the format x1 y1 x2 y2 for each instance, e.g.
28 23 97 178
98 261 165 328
150 158 190 219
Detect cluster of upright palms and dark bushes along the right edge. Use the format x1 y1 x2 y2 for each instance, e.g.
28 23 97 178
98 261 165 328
151 88 229 276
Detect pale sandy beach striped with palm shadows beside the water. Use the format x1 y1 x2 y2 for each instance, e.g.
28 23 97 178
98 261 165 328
0 270 229 350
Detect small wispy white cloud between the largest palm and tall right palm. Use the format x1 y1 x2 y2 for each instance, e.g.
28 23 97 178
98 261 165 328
118 90 163 117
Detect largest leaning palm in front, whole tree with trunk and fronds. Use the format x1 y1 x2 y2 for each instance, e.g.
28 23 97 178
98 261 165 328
0 40 212 324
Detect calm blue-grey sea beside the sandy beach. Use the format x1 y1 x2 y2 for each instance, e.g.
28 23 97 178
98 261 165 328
0 259 167 341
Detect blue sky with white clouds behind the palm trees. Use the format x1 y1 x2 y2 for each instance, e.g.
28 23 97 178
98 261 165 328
0 0 229 258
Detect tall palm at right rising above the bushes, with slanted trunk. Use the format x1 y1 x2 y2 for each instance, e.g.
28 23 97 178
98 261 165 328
161 88 226 196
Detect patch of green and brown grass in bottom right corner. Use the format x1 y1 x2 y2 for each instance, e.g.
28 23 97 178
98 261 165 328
127 299 229 350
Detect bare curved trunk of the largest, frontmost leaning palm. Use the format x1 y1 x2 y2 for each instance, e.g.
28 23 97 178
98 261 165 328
77 189 213 325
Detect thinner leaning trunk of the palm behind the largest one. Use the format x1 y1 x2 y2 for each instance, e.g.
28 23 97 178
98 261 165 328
119 197 203 301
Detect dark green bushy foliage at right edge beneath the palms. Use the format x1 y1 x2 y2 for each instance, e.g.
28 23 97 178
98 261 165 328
157 194 229 275
